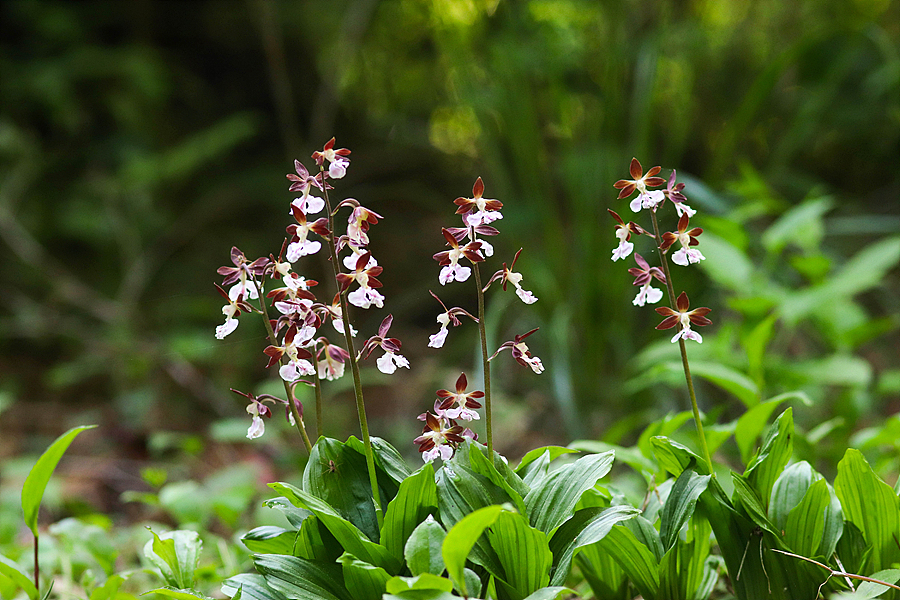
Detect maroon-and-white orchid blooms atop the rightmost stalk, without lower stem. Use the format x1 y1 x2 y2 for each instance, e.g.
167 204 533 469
607 158 712 343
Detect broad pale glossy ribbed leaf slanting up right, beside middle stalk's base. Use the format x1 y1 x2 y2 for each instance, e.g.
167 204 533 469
525 452 614 536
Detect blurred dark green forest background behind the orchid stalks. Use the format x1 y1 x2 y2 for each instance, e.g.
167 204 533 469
0 0 900 520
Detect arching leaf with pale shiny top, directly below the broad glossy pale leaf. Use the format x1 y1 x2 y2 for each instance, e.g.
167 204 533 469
550 505 641 585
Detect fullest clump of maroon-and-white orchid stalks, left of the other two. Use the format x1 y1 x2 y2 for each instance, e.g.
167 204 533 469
216 138 400 525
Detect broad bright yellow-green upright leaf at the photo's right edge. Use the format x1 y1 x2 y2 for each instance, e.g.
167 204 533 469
834 448 900 571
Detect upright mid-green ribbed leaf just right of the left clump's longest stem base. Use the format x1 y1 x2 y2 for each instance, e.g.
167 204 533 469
381 464 440 559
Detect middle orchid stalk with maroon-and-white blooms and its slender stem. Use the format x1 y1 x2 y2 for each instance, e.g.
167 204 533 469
424 177 544 462
